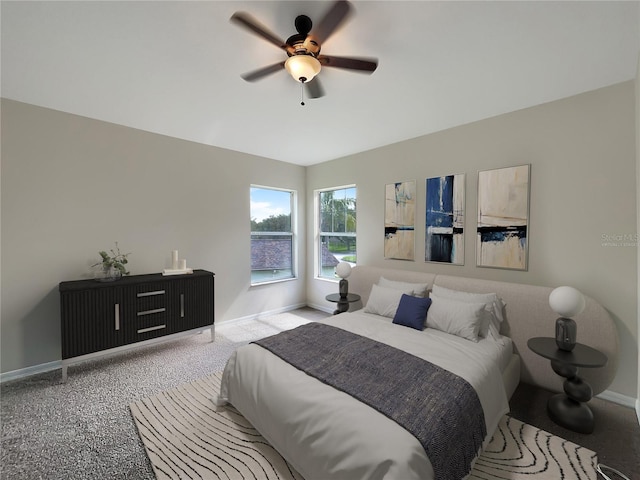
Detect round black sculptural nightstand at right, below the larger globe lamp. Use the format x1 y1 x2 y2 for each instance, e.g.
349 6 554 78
527 337 607 433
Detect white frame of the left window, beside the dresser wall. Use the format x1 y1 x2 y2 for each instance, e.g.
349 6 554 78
249 184 298 287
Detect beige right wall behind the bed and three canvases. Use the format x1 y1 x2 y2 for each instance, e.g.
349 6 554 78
307 81 638 398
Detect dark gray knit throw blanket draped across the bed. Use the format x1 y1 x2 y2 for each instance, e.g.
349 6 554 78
254 323 487 480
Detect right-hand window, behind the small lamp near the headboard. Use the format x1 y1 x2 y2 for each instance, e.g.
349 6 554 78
316 186 356 278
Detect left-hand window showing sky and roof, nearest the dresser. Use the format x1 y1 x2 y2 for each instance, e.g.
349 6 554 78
251 185 296 285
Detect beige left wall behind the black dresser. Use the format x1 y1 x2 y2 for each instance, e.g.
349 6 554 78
1 100 306 372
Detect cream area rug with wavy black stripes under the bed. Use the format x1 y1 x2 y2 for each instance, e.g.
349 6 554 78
130 373 597 480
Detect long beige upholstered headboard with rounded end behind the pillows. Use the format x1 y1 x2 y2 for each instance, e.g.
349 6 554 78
349 266 618 394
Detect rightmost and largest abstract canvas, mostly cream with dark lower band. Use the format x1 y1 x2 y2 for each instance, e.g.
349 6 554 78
476 165 530 270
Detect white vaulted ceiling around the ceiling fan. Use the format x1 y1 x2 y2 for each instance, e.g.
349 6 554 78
1 1 640 165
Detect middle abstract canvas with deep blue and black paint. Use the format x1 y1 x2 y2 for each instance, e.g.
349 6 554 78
424 173 465 265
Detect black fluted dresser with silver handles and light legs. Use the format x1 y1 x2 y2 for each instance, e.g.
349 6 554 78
59 270 215 380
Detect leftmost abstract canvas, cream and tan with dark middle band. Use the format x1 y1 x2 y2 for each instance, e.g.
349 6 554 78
384 181 416 260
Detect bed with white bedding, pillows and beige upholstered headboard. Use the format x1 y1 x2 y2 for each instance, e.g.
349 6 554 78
214 267 617 480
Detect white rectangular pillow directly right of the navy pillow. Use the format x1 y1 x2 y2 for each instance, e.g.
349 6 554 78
427 297 485 342
